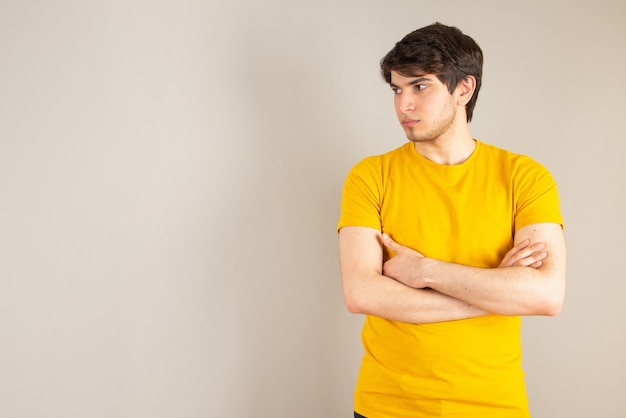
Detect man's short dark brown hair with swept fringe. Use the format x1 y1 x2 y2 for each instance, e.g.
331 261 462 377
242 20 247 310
380 22 483 122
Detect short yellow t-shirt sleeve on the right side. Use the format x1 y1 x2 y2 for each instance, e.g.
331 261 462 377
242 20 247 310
514 157 563 230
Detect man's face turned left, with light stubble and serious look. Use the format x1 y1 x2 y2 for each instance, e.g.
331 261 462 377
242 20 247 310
390 71 464 142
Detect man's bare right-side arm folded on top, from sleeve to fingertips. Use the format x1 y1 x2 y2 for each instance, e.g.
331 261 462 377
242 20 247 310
383 223 566 315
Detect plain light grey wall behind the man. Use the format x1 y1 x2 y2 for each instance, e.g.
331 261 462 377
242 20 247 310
0 0 626 418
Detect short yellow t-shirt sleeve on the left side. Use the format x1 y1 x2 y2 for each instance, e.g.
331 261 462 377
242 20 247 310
337 157 382 230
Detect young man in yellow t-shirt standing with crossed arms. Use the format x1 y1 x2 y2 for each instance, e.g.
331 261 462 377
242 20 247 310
338 23 565 418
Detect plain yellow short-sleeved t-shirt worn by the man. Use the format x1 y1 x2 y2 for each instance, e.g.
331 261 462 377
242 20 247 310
338 141 562 418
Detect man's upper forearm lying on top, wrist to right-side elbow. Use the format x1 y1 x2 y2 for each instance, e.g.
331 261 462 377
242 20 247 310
423 259 564 315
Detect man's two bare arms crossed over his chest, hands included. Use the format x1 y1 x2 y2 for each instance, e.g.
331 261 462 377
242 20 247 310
339 223 566 323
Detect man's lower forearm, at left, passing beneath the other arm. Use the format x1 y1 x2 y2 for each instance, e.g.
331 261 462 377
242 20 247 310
344 275 486 324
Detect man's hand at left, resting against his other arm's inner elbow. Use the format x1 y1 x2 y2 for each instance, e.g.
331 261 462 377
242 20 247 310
382 234 426 289
